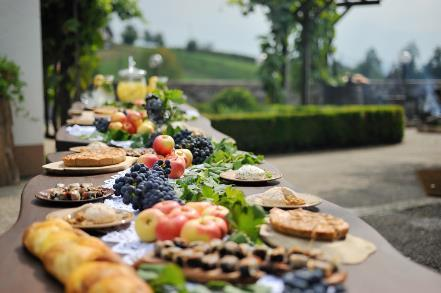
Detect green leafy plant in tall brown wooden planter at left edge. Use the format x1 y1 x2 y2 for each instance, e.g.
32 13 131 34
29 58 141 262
0 57 24 186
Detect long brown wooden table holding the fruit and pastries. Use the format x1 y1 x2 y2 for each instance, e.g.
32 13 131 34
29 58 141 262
0 113 441 292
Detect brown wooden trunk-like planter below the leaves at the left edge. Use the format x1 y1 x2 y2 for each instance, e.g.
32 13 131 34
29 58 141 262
0 97 20 186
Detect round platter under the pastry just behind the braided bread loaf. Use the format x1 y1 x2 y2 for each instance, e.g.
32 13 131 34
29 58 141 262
46 207 133 229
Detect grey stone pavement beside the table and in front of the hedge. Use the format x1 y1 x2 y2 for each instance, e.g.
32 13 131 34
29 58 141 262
0 129 441 271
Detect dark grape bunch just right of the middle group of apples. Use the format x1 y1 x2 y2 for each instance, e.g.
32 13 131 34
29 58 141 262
175 134 213 164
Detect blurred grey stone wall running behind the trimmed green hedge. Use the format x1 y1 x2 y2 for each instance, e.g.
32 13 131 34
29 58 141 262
169 79 441 118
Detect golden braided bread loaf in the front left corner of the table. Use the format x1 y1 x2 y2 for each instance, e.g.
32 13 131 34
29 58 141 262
23 219 153 293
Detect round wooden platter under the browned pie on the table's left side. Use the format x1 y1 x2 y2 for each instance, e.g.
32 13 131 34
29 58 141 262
42 156 137 175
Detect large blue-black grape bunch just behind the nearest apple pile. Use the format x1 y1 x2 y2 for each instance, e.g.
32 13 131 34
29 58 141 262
113 160 180 210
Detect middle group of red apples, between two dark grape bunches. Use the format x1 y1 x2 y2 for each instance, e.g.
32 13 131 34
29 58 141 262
138 135 193 179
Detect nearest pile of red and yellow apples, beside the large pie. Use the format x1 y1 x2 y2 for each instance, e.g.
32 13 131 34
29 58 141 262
135 200 228 242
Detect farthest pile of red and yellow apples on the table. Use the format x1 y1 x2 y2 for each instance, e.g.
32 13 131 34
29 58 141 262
109 110 155 134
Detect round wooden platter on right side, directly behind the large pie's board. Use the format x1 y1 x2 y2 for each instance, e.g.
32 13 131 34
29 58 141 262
246 192 322 209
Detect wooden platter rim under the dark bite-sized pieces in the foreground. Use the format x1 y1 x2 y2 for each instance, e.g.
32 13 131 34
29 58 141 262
133 255 265 284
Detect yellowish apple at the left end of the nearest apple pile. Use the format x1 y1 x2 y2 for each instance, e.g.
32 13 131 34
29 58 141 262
135 209 165 242
